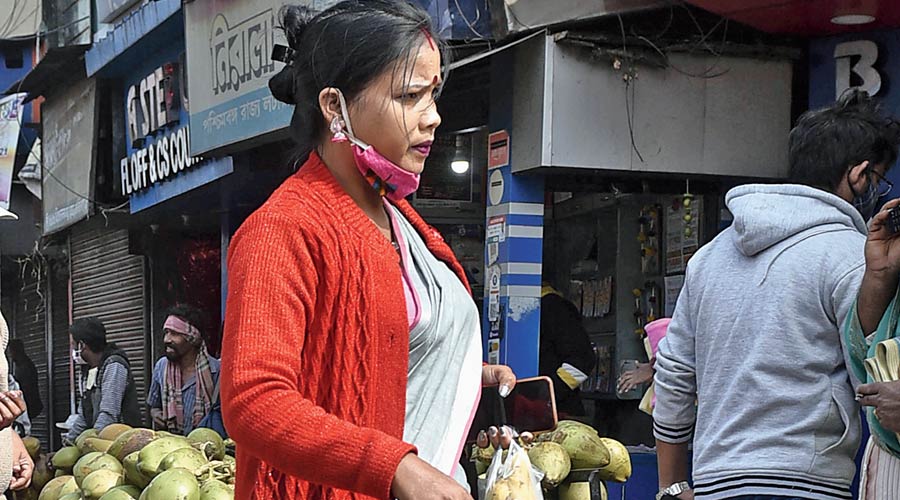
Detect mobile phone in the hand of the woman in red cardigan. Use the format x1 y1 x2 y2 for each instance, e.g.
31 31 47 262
466 377 558 443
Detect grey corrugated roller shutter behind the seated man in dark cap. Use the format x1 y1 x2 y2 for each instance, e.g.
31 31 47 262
70 230 150 424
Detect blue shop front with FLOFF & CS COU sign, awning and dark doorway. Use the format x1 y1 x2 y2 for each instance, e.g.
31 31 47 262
86 0 253 362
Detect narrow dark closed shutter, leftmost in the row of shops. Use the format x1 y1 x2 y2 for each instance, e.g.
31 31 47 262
12 261 50 451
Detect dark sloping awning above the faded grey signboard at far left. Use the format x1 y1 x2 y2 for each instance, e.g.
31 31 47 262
4 45 90 102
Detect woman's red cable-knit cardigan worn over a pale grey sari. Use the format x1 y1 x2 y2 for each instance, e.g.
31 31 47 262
221 153 468 500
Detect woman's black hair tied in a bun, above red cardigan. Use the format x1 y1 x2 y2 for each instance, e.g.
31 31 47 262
269 0 449 158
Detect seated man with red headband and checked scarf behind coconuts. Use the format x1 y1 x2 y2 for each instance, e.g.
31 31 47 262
147 304 219 435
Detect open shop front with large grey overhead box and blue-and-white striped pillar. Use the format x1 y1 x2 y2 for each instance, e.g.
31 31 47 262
483 34 793 500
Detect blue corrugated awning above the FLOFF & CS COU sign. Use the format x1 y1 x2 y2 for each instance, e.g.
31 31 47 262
84 0 184 76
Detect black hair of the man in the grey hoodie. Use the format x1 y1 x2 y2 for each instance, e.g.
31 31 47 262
789 89 900 191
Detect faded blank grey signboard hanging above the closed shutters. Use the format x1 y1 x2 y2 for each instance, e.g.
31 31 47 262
41 78 97 235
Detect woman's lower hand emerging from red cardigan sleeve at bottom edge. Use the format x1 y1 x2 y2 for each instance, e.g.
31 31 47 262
391 453 472 500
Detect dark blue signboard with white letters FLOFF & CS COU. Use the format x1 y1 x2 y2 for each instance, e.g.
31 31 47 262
119 43 233 213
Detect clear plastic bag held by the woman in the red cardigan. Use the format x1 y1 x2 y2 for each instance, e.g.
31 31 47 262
484 441 544 500
